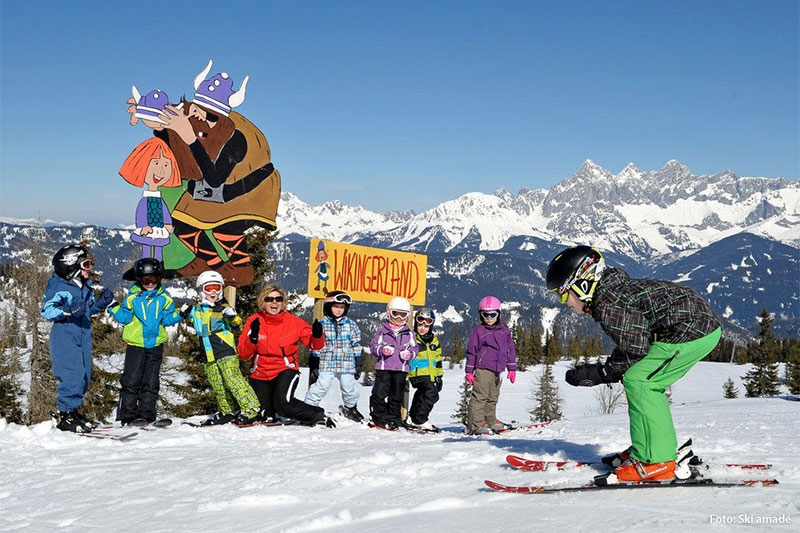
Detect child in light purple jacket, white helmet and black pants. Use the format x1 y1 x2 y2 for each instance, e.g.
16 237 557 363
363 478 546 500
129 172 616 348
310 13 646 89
369 297 419 429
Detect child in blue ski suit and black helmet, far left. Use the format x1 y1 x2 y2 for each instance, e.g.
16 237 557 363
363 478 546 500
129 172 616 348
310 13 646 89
41 244 114 432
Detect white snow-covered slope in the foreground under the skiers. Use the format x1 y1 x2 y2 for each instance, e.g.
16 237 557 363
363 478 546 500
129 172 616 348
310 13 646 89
0 363 800 533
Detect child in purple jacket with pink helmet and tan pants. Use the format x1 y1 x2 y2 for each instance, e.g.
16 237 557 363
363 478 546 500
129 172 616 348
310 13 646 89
465 296 517 435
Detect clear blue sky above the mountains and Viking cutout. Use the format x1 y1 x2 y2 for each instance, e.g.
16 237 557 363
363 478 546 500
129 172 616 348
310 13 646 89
0 0 800 224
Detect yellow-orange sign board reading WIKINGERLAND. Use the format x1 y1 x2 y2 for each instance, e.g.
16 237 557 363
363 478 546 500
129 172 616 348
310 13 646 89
308 239 428 306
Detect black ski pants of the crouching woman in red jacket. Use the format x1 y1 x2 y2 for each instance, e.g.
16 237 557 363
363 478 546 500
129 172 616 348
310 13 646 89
250 369 325 425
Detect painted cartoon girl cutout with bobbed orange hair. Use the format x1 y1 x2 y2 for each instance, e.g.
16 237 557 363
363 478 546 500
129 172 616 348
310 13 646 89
119 137 181 261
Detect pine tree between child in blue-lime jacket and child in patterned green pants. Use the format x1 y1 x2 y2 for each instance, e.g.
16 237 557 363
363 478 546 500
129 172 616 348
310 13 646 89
161 324 218 418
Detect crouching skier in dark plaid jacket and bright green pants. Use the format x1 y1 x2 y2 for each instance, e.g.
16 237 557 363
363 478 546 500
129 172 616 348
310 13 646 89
545 246 722 483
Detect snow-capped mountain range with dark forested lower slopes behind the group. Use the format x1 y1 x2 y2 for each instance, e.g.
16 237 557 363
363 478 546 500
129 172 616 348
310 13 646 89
0 160 800 336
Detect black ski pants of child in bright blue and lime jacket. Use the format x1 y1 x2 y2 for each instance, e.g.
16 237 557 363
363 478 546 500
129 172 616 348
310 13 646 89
117 344 164 422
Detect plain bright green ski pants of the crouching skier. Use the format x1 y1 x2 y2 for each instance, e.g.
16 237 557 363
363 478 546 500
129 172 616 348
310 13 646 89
622 328 722 463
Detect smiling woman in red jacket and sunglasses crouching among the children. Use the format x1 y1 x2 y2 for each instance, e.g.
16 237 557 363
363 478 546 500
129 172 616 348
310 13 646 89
238 285 330 425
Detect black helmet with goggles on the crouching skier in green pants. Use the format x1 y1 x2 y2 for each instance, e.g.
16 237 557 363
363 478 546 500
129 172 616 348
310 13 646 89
545 245 605 305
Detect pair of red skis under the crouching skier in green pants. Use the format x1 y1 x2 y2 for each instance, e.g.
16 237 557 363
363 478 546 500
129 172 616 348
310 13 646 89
485 439 778 494
